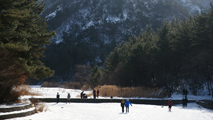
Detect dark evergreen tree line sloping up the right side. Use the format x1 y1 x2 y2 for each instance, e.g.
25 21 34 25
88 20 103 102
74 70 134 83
102 4 213 94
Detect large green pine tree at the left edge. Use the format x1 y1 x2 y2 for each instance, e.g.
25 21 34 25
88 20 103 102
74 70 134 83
0 0 55 102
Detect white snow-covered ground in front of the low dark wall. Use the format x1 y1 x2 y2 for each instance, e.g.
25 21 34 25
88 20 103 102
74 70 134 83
8 103 213 120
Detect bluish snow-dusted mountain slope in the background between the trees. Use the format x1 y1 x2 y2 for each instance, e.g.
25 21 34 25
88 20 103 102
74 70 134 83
42 0 211 80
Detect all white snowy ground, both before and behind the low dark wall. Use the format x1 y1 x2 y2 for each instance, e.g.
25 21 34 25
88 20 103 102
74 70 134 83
0 86 213 120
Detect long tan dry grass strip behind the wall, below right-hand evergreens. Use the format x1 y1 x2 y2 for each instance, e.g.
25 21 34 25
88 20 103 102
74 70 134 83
95 85 163 98
